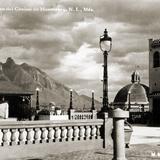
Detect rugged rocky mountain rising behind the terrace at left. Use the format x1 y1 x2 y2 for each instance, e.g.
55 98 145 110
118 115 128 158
0 57 101 110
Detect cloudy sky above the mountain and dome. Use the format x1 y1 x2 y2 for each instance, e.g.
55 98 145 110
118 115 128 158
0 0 160 102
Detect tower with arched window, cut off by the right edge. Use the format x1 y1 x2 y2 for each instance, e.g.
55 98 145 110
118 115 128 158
149 39 160 125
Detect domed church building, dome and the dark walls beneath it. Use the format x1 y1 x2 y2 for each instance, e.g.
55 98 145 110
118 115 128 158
113 71 149 123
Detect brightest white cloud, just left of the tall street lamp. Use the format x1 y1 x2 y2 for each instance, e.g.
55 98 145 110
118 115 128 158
54 43 101 80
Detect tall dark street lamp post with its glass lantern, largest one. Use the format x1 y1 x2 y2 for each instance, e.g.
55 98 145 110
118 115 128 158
99 29 112 112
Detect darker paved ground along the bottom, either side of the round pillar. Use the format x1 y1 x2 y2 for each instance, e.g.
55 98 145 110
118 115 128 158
13 144 160 160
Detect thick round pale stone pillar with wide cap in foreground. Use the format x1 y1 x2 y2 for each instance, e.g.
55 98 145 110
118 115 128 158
112 108 129 160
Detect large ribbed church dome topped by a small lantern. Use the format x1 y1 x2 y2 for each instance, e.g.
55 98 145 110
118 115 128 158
113 71 149 107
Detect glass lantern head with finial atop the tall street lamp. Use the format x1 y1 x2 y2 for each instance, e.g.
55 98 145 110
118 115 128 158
99 29 112 52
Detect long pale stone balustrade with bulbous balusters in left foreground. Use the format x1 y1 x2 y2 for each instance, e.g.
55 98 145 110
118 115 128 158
0 119 103 146
